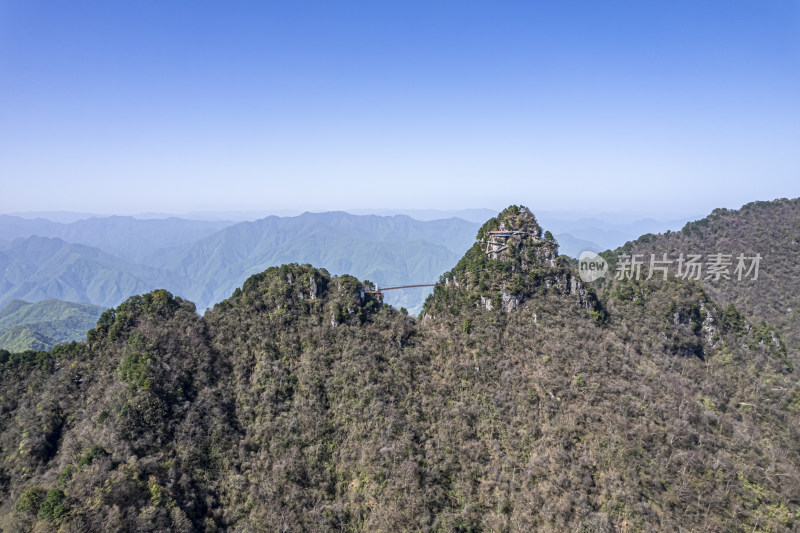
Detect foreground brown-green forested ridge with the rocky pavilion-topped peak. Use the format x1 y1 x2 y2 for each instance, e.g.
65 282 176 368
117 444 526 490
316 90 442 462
0 206 800 532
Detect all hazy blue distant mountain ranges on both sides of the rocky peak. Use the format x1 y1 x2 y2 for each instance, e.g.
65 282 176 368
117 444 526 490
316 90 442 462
0 209 692 313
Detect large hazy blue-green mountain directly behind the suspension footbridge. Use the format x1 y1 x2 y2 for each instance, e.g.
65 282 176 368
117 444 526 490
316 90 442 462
153 212 484 309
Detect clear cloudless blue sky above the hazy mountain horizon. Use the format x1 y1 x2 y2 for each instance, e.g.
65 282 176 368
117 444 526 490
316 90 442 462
0 0 800 214
